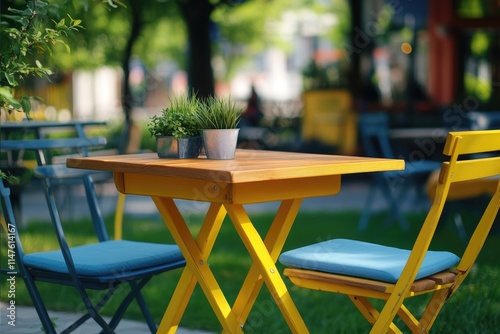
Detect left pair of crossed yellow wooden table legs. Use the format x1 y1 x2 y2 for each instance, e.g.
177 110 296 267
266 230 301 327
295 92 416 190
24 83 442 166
153 197 243 333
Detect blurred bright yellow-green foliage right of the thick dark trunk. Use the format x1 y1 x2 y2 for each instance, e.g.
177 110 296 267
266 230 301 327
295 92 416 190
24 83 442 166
212 0 351 80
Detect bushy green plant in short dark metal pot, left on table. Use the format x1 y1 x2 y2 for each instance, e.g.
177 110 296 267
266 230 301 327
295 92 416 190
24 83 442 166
148 95 201 159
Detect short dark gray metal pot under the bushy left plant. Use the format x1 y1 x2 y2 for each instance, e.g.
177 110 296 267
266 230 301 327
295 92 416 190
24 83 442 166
156 136 201 159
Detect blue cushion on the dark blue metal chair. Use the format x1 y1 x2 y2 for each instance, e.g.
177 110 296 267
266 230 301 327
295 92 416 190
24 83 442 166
24 240 184 276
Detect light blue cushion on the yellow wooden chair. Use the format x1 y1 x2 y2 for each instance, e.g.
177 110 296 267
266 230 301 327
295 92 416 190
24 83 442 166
279 239 460 283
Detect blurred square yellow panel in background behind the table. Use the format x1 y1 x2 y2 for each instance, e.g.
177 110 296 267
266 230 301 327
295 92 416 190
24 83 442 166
302 89 357 154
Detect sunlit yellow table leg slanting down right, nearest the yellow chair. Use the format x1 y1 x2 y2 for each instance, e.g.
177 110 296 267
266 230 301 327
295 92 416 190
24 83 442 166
225 204 309 334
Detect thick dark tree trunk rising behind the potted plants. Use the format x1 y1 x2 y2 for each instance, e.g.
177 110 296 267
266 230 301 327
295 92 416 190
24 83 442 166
177 0 215 98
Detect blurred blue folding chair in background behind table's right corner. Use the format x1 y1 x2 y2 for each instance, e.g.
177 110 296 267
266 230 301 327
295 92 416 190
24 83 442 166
358 112 441 230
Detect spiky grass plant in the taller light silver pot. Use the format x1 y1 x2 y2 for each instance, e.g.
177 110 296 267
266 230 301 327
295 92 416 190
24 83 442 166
196 97 243 159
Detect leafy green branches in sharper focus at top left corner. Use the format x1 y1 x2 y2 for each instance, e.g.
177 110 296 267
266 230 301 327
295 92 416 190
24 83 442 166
0 0 81 115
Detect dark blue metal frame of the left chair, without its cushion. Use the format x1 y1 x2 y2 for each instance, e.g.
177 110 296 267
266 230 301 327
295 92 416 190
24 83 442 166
0 137 185 333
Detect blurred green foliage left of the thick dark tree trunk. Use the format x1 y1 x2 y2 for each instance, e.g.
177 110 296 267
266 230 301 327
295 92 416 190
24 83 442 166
45 0 186 70
